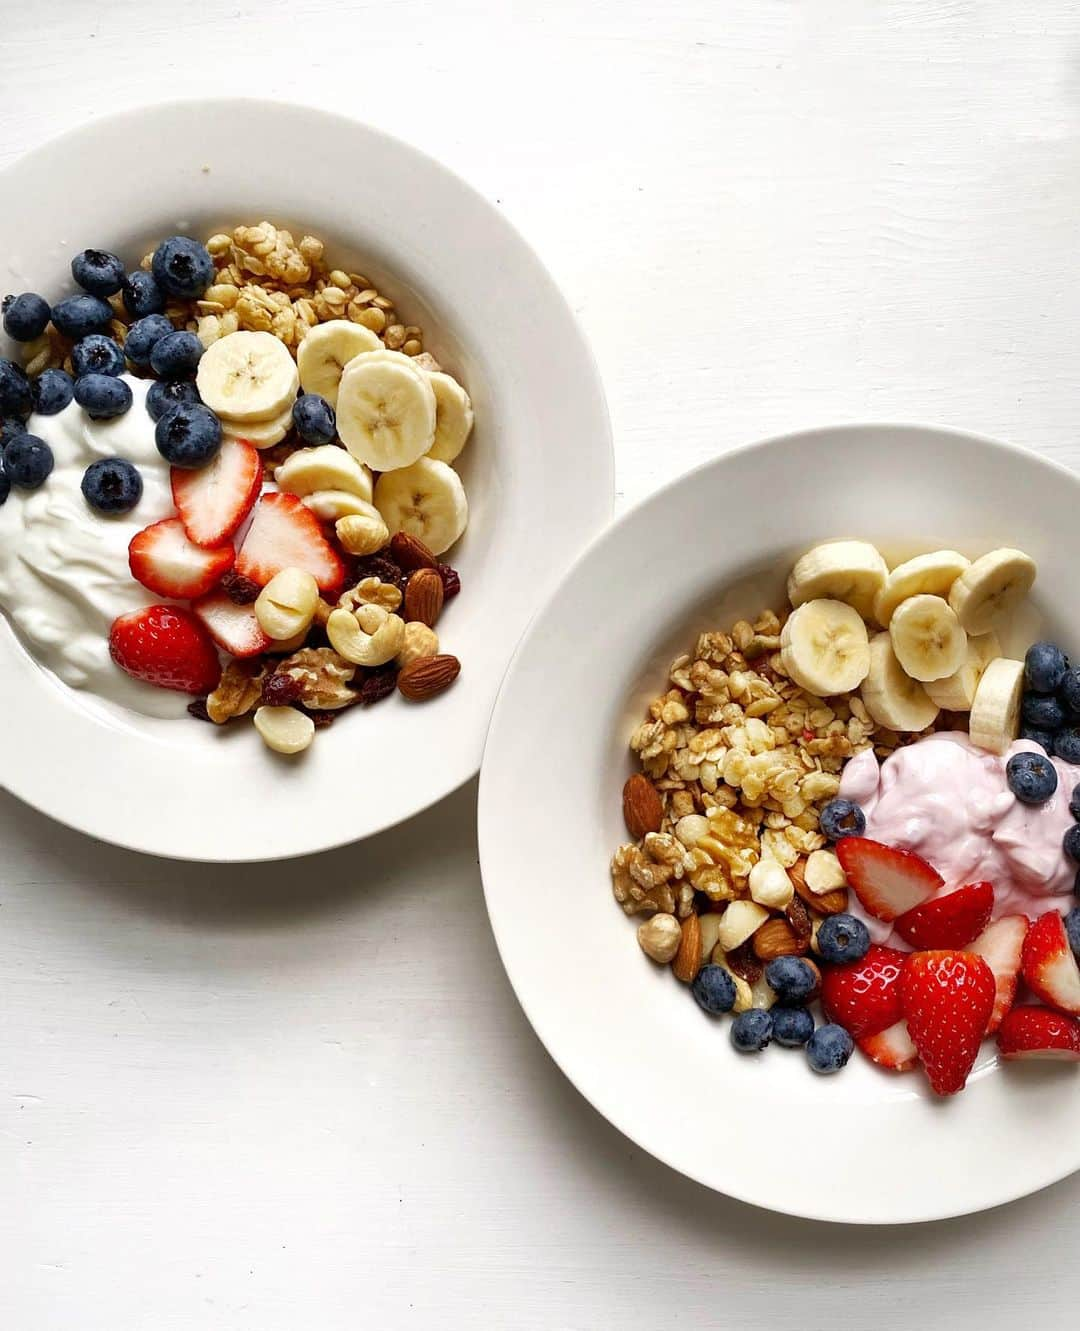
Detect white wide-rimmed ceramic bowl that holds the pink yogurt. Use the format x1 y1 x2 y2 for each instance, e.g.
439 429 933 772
479 426 1080 1222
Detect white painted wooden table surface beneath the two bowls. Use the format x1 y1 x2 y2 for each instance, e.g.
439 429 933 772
0 0 1080 1331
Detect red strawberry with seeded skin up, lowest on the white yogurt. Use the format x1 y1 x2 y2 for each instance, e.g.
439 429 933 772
109 606 221 693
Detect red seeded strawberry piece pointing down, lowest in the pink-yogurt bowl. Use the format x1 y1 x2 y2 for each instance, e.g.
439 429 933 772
900 952 996 1095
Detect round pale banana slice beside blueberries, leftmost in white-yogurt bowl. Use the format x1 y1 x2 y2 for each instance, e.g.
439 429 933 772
194 333 300 421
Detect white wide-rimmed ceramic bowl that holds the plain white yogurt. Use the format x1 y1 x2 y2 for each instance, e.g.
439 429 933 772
0 101 613 860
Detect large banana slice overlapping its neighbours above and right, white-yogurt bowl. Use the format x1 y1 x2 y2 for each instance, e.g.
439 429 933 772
337 351 435 471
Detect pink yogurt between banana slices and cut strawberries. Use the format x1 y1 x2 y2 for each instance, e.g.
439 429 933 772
840 731 1080 946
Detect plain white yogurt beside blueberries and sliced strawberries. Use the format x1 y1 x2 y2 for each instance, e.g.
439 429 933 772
0 374 189 716
